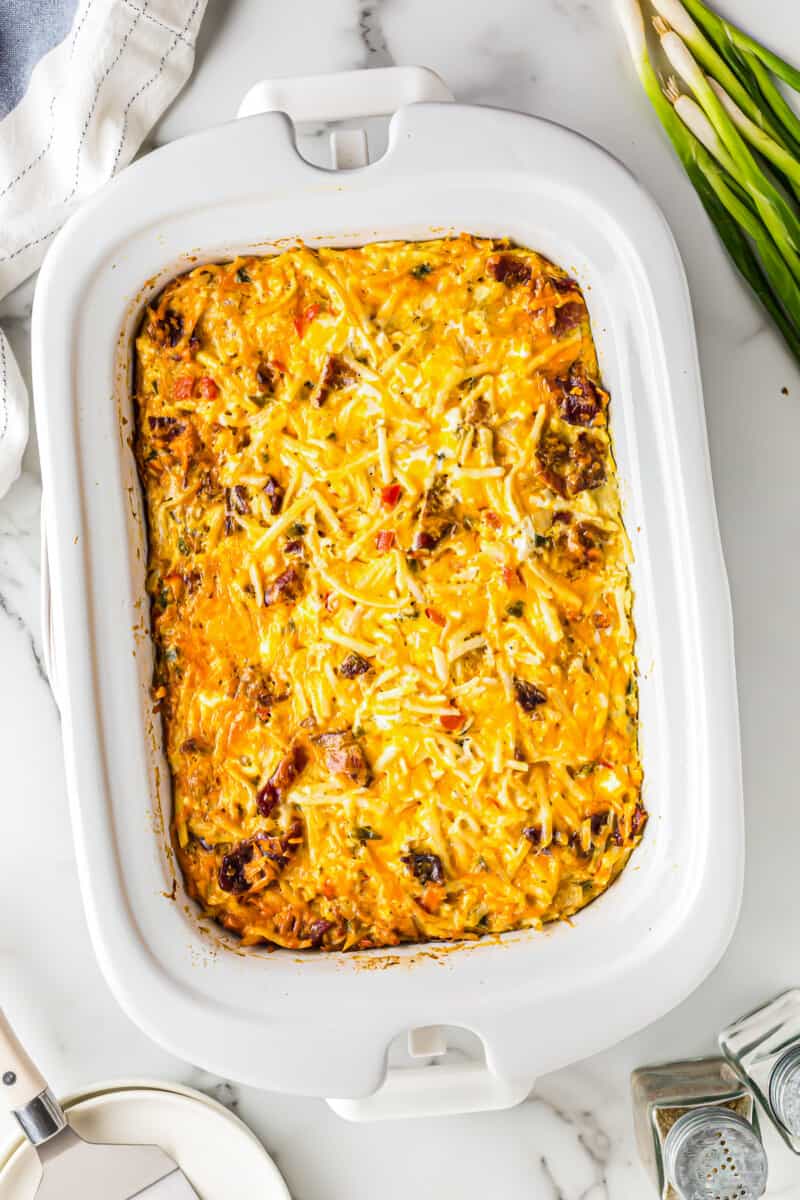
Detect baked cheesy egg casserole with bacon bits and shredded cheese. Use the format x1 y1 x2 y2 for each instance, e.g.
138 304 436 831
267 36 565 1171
134 235 646 950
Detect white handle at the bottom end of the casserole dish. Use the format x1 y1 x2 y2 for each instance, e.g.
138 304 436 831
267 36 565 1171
327 1062 536 1121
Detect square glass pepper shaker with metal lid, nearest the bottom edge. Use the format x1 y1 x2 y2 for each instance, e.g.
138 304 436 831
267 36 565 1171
631 1058 766 1200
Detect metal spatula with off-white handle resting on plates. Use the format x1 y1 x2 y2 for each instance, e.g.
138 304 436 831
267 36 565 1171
0 1009 198 1200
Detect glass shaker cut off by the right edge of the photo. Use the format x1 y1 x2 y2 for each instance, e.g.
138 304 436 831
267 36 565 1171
720 988 800 1154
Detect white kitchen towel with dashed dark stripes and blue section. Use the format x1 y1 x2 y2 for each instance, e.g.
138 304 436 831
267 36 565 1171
0 0 206 496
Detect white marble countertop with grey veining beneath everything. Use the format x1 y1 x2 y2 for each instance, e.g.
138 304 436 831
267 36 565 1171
0 0 800 1200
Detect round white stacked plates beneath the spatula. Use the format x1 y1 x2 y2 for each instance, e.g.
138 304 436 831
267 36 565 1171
0 1086 289 1200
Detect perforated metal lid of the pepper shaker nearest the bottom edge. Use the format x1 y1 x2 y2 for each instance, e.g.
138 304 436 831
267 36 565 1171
664 1105 766 1200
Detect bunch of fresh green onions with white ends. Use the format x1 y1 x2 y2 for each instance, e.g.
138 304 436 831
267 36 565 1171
616 0 800 362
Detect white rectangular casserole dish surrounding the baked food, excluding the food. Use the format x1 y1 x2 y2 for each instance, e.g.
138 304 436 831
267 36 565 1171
34 70 744 1116
